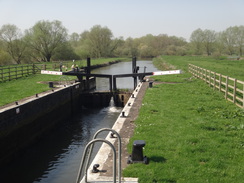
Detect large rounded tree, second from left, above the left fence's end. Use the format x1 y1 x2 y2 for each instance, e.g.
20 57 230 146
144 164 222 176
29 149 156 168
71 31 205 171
26 20 68 62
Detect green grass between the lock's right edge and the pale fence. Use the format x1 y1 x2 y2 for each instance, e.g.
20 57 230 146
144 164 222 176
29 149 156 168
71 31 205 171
123 57 244 183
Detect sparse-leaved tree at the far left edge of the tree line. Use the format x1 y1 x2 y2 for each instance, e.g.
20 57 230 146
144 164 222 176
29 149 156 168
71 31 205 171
0 24 26 64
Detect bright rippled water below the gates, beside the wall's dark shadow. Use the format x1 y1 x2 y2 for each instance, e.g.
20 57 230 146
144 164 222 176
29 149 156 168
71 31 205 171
35 106 121 183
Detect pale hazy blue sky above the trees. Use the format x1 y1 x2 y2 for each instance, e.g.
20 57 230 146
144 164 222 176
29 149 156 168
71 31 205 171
0 0 244 40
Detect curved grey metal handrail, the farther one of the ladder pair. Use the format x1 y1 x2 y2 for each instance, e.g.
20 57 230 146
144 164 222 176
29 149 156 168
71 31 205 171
85 128 121 183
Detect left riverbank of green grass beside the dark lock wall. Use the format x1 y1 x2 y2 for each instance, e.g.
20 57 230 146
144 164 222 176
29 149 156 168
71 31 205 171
0 59 126 106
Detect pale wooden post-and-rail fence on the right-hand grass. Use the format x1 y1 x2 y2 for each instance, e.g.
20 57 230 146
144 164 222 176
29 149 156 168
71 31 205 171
188 64 244 108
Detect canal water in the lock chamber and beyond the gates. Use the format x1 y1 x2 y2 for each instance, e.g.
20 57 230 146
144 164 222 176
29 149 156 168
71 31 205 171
0 61 157 183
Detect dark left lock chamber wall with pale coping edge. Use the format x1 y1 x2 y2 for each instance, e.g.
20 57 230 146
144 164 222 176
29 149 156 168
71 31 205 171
0 78 95 164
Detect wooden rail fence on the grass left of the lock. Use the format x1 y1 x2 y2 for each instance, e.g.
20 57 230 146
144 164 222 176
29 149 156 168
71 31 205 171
0 64 39 82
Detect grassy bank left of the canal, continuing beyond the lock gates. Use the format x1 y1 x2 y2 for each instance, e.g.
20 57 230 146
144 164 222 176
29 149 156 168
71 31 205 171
0 58 126 106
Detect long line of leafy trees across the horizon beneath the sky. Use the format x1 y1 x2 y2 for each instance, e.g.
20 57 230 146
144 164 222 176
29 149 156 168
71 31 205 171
0 20 244 65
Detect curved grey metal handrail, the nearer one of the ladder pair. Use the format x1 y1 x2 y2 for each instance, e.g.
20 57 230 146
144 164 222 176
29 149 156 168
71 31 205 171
76 139 116 183
